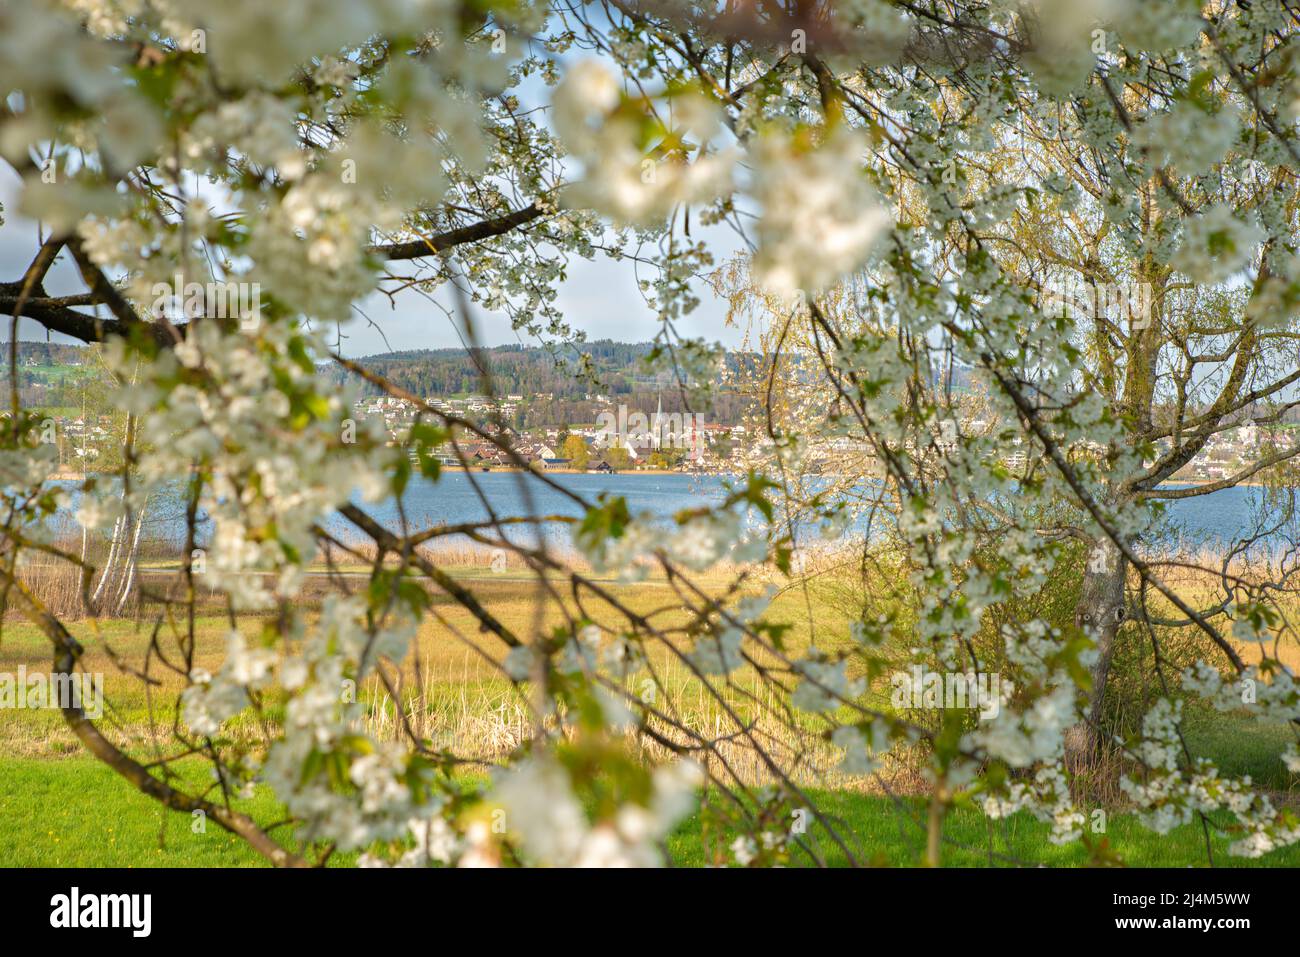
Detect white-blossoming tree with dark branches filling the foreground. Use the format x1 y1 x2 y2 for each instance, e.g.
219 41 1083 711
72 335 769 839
0 0 1300 865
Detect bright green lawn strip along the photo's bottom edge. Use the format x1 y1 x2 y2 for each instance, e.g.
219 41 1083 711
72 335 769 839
0 755 1300 867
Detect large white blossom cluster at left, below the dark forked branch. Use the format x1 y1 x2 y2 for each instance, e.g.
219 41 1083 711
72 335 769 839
105 321 389 609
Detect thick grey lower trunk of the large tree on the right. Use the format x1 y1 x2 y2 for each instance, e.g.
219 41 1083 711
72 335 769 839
1065 540 1127 767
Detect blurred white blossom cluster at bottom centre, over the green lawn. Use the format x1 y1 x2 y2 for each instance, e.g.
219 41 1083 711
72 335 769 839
493 754 703 867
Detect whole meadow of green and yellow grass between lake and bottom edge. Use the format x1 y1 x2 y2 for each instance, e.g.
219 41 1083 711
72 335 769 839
0 546 1300 867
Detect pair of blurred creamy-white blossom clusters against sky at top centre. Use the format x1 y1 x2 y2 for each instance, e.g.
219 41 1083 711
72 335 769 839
553 60 893 294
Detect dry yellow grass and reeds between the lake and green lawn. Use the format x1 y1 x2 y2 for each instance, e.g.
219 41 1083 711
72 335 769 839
0 546 1300 793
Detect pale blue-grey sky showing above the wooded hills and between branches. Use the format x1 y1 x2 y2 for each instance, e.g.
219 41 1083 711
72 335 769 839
0 155 744 356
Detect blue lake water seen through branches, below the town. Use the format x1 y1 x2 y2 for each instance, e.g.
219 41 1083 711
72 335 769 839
56 472 1296 549
